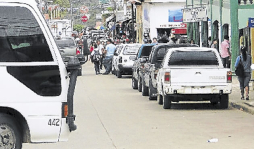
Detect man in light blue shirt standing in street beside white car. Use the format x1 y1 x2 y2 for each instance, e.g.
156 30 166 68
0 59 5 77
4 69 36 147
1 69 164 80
103 39 116 75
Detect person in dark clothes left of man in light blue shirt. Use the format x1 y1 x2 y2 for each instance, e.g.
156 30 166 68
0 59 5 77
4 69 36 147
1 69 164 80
91 44 102 75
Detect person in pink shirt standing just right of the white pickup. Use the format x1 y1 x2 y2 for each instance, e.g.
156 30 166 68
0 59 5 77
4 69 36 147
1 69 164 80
220 35 231 68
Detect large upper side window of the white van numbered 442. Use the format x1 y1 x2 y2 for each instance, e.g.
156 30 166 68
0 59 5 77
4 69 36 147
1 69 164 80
0 6 53 62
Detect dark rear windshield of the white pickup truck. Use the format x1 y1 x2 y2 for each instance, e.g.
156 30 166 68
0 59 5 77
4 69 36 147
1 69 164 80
168 51 219 66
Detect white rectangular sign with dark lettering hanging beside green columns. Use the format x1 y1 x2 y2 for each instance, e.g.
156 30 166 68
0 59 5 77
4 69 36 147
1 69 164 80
183 7 207 22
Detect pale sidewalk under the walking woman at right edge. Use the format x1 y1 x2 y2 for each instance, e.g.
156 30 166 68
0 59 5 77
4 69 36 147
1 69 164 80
229 76 254 114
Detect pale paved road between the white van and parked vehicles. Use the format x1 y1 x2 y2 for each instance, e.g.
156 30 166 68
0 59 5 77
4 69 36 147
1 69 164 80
23 63 254 149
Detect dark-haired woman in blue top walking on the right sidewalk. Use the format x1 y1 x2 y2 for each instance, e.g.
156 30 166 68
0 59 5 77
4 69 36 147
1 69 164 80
235 47 252 100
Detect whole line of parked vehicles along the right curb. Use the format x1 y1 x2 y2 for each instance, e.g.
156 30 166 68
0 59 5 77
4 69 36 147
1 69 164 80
112 43 232 109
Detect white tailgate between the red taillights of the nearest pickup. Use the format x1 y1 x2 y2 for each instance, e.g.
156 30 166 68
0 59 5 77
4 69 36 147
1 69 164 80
170 68 228 86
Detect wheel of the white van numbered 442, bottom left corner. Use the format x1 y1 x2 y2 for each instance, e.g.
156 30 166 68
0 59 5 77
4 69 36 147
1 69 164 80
0 114 22 149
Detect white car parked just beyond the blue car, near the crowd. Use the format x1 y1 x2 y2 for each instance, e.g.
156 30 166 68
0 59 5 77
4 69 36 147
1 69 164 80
115 44 141 78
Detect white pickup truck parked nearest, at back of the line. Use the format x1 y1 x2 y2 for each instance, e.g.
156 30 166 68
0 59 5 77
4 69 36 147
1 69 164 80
157 47 232 109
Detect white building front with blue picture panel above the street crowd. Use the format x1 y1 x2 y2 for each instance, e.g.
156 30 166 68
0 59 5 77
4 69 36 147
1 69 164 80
142 0 186 38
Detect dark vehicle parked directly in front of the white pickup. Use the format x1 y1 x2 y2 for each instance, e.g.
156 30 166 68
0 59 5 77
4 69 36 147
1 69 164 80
141 44 198 100
